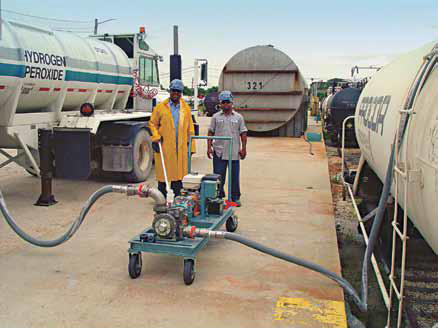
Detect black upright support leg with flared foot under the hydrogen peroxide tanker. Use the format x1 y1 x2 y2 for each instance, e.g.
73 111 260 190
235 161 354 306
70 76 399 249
35 129 57 206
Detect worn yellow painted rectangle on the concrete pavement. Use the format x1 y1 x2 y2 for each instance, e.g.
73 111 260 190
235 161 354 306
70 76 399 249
274 297 347 328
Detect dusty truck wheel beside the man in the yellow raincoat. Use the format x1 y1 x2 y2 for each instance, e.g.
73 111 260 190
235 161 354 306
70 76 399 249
126 129 153 182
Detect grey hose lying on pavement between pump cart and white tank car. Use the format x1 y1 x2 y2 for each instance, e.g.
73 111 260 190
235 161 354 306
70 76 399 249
224 232 367 312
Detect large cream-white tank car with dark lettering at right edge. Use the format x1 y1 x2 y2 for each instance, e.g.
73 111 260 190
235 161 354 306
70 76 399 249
355 42 438 254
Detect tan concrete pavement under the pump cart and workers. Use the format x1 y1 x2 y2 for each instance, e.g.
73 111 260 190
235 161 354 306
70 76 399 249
0 118 346 328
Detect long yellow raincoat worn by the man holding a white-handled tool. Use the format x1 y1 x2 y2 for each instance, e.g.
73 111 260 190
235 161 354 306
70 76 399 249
149 98 195 183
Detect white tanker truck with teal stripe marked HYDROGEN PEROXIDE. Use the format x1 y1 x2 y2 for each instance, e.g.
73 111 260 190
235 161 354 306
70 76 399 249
0 21 162 182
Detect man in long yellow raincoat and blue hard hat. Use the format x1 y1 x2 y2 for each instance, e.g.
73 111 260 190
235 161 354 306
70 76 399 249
149 79 195 197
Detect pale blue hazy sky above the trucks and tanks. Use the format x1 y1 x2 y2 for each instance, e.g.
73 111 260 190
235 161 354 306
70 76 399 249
1 0 438 86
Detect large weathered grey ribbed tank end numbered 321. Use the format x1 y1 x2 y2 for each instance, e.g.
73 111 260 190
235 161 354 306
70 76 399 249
219 45 308 137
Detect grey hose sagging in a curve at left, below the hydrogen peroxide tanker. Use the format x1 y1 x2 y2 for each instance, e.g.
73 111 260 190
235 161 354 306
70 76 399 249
0 186 113 247
